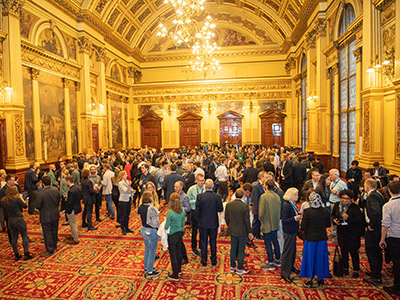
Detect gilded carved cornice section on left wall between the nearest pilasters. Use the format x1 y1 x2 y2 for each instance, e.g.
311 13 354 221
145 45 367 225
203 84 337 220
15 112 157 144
21 41 81 80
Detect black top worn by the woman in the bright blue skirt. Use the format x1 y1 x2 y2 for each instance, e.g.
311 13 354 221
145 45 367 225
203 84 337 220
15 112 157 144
301 207 331 242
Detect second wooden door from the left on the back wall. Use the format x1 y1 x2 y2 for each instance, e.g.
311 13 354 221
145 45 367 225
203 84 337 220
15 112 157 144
177 112 203 148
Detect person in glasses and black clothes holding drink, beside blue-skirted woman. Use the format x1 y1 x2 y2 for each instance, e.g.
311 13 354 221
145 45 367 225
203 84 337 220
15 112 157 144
331 189 363 278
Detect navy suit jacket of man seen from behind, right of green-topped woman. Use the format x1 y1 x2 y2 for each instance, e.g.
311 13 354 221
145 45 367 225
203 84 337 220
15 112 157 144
196 191 224 229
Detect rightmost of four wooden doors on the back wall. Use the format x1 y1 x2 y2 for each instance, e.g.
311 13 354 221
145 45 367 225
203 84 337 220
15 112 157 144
260 110 286 147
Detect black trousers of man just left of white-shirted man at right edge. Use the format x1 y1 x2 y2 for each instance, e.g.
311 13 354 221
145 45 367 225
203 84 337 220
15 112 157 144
365 228 383 279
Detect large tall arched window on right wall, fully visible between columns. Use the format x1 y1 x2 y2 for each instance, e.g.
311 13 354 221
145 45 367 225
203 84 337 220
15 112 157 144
338 4 356 172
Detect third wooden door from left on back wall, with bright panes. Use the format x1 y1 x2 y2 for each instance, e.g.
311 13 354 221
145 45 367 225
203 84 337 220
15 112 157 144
218 110 243 146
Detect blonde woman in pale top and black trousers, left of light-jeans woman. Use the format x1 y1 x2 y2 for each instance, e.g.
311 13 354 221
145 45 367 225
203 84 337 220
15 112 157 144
117 171 133 235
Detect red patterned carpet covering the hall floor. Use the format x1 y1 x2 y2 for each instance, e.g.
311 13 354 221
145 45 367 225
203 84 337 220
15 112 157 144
0 204 395 300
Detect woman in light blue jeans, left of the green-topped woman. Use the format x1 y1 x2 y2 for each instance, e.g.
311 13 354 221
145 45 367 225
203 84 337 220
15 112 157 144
138 192 160 277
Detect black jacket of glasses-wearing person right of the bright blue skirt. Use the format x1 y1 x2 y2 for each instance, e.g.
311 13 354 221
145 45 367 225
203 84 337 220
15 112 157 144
331 202 364 248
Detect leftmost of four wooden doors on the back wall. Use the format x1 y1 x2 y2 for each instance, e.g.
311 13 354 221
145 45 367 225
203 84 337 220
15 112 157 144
139 114 162 151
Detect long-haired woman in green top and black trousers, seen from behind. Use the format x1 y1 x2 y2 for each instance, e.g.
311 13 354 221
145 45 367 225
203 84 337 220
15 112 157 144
165 193 185 280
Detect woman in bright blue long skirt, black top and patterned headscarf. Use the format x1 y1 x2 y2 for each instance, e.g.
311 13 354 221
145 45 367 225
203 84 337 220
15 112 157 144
300 191 331 287
